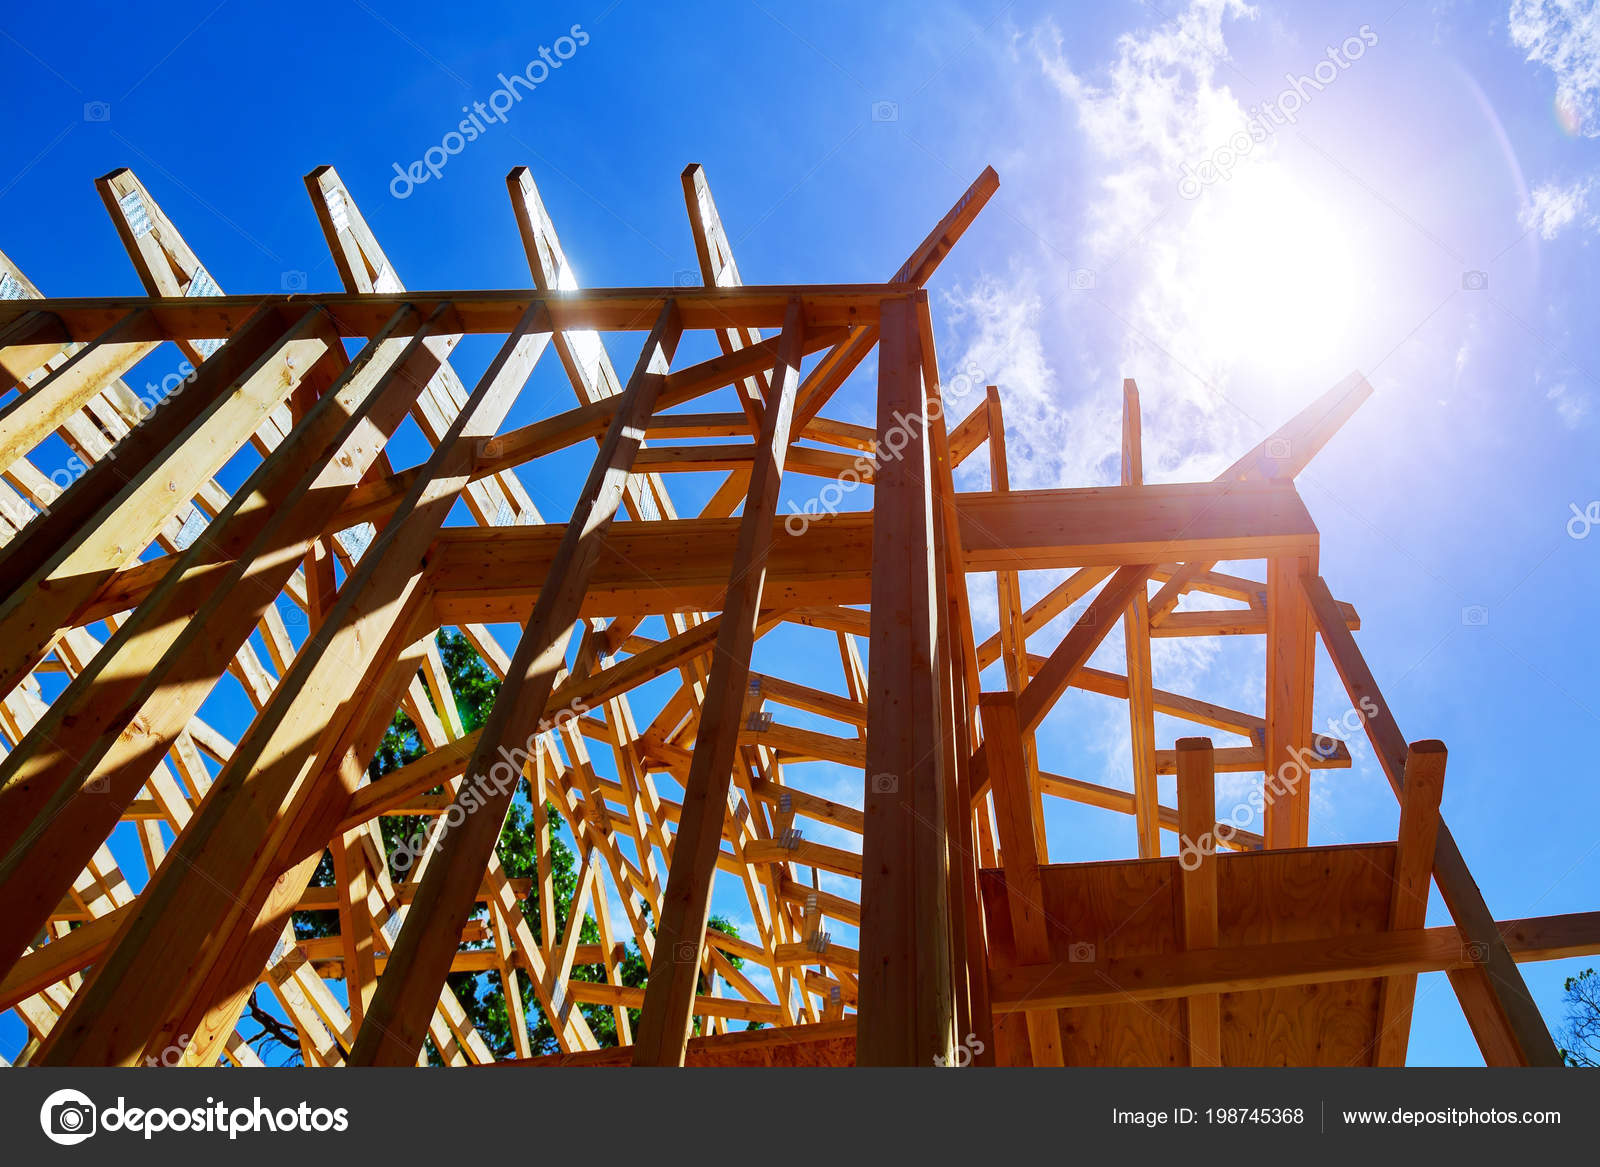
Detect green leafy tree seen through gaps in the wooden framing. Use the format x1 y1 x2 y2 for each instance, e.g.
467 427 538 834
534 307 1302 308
250 629 744 1065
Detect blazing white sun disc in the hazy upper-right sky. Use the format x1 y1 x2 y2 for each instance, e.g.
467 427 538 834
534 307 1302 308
1186 163 1368 371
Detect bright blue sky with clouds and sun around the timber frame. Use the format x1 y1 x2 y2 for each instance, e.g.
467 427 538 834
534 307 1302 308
0 0 1600 1063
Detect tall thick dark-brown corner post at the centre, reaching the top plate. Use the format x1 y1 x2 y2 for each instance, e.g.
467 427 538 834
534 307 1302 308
856 292 955 1066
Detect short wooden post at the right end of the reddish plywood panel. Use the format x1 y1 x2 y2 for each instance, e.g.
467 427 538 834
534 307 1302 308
1374 741 1445 1066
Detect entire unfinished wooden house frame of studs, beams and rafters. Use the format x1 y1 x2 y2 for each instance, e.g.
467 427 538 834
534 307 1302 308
0 166 1600 1065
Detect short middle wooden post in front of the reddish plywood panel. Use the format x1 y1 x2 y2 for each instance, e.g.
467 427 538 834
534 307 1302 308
1178 738 1222 1066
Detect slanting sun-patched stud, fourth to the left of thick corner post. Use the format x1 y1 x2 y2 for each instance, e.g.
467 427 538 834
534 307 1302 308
0 312 451 968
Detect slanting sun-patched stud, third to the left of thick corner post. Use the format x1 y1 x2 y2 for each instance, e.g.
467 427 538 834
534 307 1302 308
40 307 547 1065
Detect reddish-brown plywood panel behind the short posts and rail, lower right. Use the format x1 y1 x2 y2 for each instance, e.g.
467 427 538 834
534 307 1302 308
982 844 1394 1066
